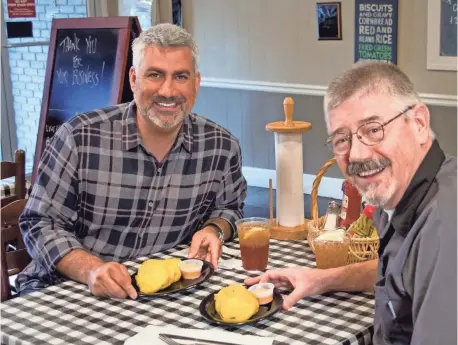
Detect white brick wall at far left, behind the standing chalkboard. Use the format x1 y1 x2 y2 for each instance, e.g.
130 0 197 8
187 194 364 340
2 0 87 172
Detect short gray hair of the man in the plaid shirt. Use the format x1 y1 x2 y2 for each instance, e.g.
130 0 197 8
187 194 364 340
132 23 199 72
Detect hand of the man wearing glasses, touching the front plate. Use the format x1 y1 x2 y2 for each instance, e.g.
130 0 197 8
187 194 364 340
245 267 326 310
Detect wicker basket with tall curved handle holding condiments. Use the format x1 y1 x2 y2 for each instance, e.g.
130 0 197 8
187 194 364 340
307 158 379 264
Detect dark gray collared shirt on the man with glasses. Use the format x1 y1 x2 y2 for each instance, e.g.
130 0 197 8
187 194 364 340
373 141 457 345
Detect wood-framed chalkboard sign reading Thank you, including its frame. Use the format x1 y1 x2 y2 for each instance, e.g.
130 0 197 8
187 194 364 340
32 17 141 182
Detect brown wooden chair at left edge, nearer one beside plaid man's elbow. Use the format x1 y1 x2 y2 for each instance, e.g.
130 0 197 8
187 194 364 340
0 199 31 301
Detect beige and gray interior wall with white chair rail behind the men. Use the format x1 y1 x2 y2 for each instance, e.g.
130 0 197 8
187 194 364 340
182 0 457 198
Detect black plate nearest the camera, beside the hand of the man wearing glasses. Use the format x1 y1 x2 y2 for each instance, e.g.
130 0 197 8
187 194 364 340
199 289 283 326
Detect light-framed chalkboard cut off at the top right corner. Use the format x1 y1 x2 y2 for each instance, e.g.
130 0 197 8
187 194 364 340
427 0 458 71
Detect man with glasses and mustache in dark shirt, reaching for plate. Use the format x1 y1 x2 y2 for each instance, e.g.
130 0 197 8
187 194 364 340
246 62 457 345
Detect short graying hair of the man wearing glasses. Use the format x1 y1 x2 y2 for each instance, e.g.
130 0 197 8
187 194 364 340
323 61 434 138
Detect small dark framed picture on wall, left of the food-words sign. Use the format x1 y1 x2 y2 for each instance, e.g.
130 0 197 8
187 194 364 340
316 2 342 40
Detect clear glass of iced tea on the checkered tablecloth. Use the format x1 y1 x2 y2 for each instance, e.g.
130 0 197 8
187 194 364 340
235 217 272 271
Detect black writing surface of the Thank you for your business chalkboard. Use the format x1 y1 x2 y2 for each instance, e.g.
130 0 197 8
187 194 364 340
44 29 119 140
